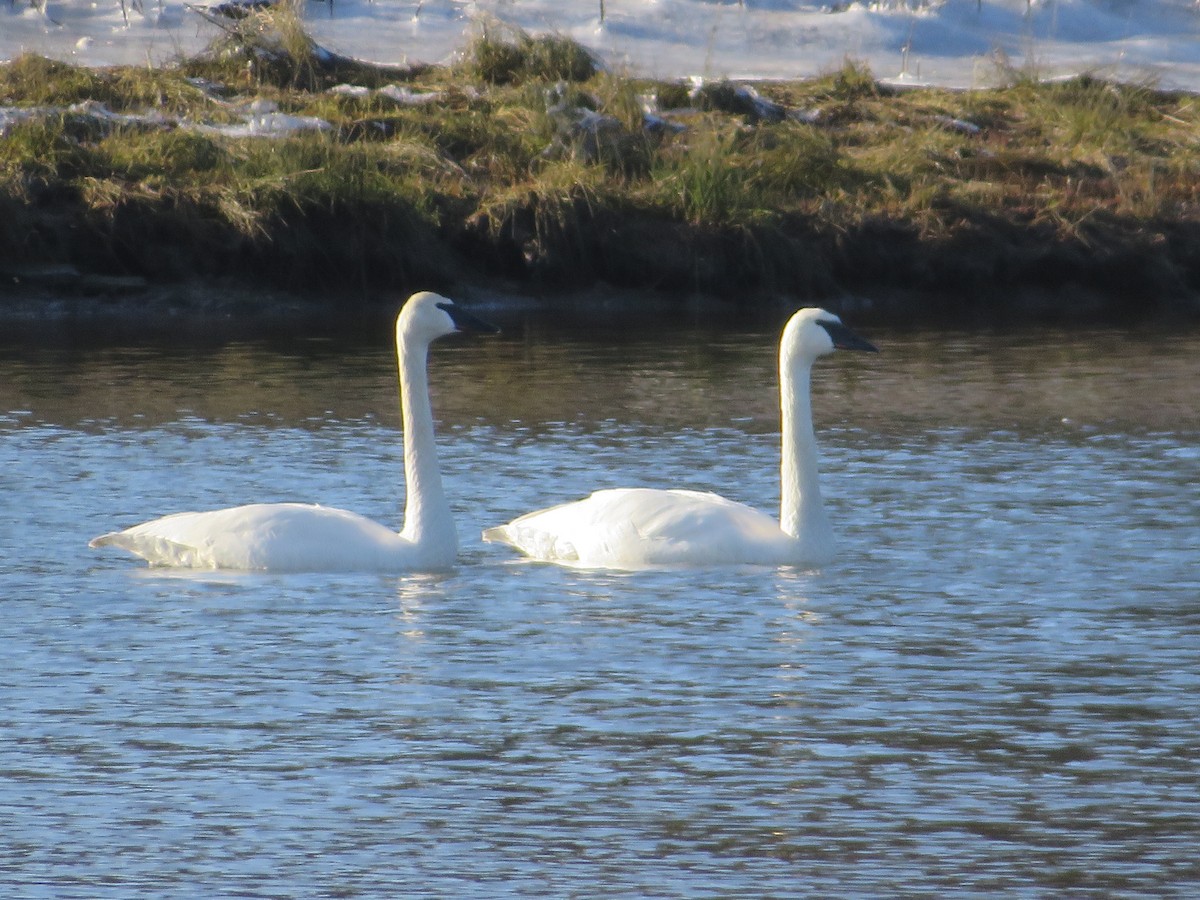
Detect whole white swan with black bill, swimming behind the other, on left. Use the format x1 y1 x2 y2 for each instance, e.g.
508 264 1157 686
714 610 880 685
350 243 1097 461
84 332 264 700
89 290 499 571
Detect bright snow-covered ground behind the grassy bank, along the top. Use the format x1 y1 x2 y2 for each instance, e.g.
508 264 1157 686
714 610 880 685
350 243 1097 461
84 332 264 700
0 0 1200 91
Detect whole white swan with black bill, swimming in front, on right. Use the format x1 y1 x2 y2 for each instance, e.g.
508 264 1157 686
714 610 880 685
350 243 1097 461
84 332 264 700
482 308 878 570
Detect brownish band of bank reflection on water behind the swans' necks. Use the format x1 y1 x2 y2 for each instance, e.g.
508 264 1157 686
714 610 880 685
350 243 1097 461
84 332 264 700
0 312 1200 431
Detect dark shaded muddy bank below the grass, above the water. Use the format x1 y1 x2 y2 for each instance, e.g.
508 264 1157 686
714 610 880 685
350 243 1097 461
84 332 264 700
0 196 1200 323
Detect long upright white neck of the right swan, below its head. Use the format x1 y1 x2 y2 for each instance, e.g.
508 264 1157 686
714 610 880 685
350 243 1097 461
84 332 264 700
779 358 830 541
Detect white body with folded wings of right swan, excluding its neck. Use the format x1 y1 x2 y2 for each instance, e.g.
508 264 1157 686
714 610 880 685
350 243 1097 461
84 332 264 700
484 488 796 569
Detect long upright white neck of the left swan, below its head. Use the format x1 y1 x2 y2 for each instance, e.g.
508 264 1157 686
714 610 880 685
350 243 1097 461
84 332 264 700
396 336 458 548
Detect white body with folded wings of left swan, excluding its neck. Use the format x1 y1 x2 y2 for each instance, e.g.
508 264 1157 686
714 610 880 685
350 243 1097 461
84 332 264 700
90 503 413 571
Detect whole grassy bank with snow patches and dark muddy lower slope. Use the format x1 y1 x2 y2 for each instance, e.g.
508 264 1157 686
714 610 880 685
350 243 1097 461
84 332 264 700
0 13 1200 319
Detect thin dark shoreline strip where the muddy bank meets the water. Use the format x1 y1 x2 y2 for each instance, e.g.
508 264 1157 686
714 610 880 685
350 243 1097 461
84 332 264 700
0 282 1200 346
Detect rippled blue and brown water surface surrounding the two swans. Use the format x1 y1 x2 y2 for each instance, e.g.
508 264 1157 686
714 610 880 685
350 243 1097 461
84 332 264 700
0 301 1200 898
